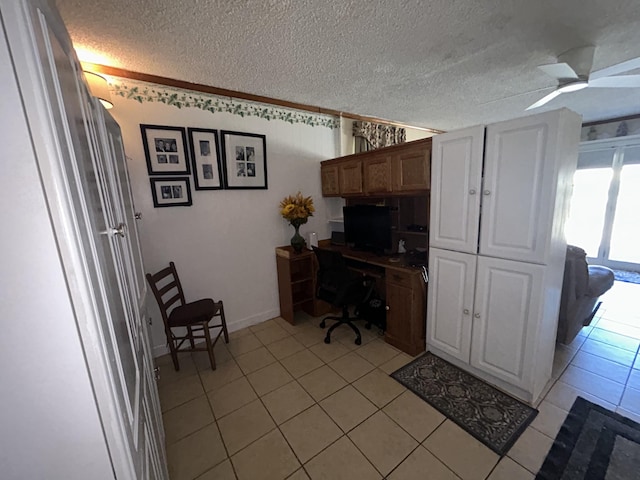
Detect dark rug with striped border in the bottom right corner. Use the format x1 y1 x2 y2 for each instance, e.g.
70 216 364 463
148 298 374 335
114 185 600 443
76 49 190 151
536 397 640 480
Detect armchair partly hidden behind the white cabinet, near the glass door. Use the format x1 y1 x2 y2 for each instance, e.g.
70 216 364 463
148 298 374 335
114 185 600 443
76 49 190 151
557 245 614 344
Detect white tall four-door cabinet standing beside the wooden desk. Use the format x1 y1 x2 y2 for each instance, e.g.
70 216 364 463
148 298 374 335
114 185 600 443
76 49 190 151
427 109 581 403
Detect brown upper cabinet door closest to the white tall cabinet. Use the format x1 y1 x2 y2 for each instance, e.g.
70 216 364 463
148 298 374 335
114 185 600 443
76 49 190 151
393 143 431 192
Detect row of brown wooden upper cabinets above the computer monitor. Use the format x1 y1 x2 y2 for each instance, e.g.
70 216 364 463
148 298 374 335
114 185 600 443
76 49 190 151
320 138 431 197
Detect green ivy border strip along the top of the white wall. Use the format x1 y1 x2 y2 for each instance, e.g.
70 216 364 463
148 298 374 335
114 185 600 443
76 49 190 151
110 77 340 129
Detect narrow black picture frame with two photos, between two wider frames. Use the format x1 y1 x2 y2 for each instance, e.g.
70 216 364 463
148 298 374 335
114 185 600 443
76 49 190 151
187 128 223 190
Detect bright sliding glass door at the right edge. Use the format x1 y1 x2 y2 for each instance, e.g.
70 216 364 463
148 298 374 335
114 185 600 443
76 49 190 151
566 137 640 271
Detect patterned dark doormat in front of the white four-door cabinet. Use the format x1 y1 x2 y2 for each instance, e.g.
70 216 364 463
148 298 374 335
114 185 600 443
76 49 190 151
391 352 538 455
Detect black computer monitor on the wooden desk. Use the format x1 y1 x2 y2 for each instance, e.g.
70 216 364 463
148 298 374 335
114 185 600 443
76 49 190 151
342 205 391 253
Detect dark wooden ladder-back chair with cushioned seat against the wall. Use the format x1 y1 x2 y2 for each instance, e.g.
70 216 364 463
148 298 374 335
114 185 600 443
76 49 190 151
146 262 229 371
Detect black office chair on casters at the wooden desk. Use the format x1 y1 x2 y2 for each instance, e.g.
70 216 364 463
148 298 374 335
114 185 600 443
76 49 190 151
313 247 375 345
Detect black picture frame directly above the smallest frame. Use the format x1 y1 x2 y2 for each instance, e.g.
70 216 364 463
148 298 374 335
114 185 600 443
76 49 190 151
140 124 191 175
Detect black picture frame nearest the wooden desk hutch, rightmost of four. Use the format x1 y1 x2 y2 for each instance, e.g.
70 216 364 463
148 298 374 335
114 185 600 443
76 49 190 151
220 130 267 190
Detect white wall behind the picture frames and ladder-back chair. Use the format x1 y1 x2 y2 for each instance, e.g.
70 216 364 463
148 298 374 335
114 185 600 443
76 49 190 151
111 88 339 355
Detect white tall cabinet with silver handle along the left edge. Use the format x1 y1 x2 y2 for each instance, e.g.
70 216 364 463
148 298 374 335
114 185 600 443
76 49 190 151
0 0 168 480
